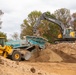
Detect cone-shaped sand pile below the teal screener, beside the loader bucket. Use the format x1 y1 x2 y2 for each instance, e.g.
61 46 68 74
30 48 63 62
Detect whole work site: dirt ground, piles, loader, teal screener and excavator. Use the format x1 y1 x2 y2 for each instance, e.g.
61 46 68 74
0 13 76 75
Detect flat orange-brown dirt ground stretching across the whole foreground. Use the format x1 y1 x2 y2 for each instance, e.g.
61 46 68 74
0 57 76 75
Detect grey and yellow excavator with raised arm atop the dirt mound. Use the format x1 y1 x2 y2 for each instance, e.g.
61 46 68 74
33 12 76 43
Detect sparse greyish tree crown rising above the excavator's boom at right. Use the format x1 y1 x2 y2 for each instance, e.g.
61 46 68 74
54 8 71 25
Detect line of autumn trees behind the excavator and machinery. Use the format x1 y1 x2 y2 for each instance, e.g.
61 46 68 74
0 8 76 43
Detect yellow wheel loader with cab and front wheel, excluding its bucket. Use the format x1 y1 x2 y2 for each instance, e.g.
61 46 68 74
0 37 21 61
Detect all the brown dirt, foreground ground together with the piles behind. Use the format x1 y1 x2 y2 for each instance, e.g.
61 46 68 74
0 43 76 75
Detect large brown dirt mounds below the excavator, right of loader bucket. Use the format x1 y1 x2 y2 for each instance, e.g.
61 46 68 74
30 43 76 62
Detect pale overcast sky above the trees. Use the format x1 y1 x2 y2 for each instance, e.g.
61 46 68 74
0 0 76 38
